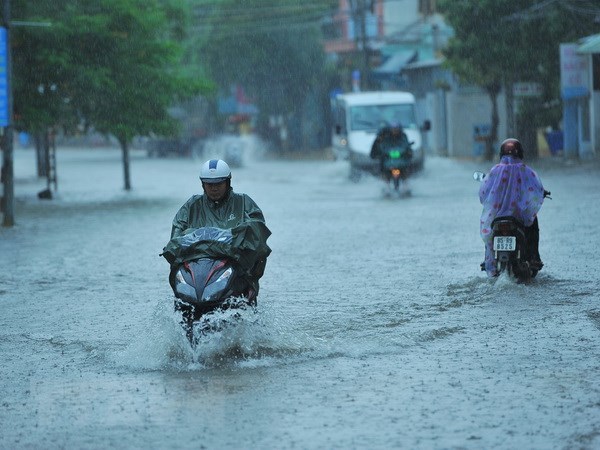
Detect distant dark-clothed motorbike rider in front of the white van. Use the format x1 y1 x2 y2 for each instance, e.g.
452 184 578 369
370 123 413 185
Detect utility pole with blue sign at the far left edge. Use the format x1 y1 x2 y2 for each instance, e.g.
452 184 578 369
0 0 15 227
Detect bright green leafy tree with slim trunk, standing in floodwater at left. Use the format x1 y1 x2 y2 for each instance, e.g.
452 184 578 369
64 0 209 190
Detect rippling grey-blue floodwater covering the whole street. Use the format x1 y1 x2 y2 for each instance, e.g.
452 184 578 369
0 139 600 449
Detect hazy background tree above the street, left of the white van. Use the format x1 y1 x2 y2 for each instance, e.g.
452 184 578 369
198 0 331 151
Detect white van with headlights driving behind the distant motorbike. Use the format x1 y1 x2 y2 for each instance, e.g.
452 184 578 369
332 91 431 181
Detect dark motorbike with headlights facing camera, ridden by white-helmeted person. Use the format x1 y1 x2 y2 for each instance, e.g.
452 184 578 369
161 227 257 345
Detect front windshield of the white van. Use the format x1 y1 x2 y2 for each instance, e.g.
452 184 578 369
350 104 417 131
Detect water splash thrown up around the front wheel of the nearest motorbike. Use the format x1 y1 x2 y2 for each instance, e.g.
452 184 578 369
113 300 319 371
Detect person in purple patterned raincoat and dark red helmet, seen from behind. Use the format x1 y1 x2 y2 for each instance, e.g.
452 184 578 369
479 138 544 276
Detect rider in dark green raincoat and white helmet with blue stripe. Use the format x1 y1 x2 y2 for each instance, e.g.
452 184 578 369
168 159 271 294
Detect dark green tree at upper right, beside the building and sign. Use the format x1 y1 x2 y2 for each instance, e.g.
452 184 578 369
438 0 600 159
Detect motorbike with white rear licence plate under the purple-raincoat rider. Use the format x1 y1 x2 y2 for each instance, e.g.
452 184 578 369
473 172 552 282
